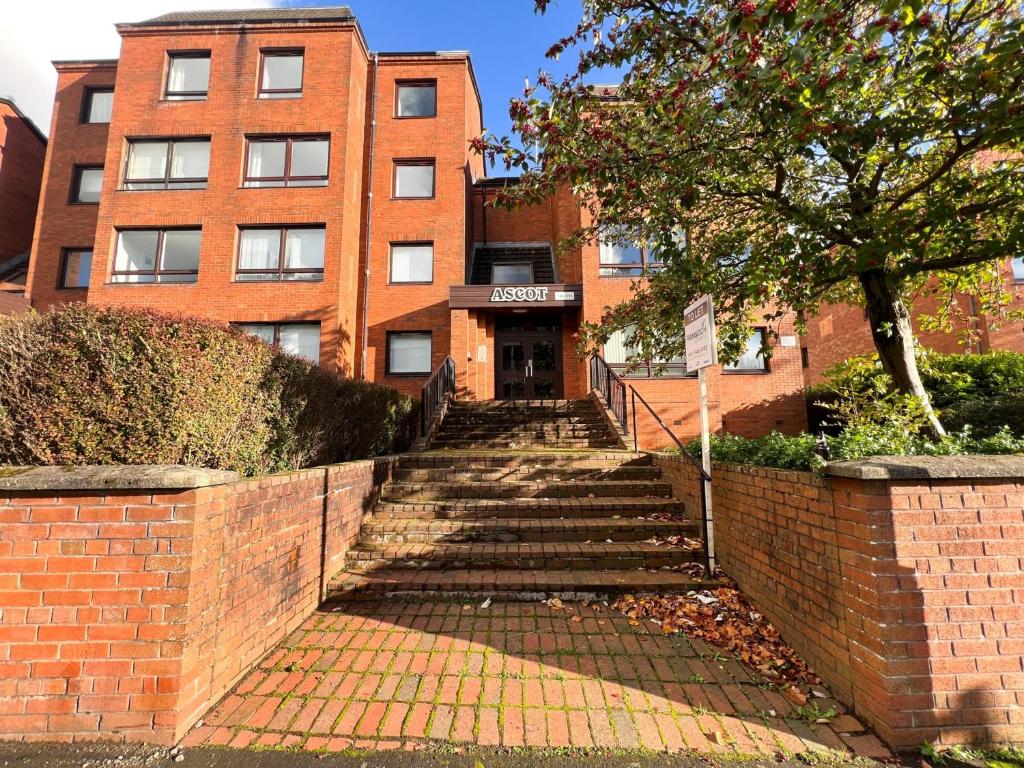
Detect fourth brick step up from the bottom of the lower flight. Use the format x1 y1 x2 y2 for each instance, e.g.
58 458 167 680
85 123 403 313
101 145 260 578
373 497 684 520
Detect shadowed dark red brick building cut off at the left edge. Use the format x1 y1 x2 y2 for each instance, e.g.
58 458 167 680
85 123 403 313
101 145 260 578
0 96 46 294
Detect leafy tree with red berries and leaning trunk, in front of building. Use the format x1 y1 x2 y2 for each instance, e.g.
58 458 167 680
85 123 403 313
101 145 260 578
474 0 1024 434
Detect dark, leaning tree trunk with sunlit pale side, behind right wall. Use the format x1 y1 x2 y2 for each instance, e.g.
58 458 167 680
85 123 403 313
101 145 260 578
858 270 946 437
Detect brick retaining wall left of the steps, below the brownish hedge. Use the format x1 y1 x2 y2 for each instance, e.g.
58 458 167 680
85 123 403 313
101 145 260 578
0 459 393 743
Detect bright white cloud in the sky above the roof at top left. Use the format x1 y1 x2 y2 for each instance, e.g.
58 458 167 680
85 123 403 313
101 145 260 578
0 0 274 133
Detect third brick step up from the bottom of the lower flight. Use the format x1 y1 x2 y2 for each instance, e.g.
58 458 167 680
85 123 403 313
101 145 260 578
360 517 699 545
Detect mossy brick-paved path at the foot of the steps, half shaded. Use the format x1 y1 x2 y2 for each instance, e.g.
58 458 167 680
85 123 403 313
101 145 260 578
184 602 885 757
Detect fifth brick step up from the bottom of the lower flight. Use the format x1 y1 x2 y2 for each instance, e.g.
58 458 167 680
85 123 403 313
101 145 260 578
384 480 672 501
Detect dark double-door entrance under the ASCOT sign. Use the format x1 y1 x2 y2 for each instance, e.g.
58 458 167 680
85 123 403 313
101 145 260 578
495 316 562 400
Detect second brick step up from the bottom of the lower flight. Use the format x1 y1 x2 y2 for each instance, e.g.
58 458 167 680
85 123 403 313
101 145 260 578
345 542 701 570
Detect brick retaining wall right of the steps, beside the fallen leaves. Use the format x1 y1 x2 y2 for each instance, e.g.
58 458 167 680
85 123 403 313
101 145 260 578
655 455 1024 749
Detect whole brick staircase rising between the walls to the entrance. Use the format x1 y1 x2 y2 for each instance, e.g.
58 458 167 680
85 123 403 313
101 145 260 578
328 400 701 602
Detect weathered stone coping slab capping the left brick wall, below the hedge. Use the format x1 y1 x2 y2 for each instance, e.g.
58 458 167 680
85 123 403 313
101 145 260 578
0 464 240 490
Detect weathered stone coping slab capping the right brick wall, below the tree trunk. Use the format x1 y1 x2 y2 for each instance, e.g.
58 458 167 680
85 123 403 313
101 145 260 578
824 456 1024 480
